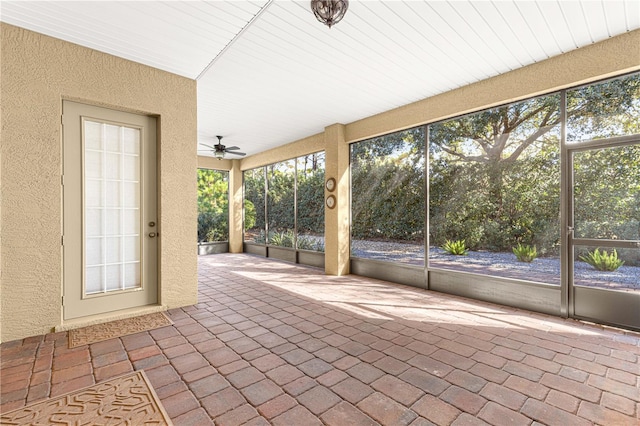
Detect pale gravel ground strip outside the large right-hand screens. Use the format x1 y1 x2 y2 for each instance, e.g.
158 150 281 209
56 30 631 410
351 240 640 290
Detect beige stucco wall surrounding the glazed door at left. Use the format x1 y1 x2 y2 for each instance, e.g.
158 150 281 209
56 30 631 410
0 24 197 341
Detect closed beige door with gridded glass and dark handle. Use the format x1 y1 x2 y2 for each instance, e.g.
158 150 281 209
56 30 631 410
62 101 159 320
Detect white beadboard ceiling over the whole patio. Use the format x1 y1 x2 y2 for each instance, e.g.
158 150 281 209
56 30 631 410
0 0 640 154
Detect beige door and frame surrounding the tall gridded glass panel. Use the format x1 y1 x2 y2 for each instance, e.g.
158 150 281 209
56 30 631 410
62 100 160 321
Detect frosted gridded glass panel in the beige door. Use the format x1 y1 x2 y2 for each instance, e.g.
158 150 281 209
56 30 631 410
84 119 142 296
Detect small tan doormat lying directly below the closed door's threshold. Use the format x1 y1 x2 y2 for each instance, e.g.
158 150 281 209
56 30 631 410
69 312 173 348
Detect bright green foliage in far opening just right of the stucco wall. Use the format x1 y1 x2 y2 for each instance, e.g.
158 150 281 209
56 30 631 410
198 169 229 242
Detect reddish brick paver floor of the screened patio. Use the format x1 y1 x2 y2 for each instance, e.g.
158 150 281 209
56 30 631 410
0 254 640 426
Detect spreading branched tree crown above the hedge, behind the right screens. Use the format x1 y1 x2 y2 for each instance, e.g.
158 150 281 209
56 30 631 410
429 74 640 169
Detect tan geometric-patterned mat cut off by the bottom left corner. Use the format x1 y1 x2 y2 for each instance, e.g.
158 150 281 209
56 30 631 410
0 371 172 426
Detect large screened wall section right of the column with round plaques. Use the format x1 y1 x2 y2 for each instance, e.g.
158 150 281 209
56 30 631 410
351 73 640 328
